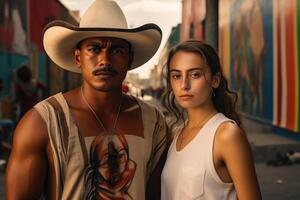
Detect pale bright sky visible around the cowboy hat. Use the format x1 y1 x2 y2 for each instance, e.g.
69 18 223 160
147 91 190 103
60 0 181 78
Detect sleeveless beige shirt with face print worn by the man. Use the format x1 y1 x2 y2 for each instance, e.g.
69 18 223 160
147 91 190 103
35 93 166 200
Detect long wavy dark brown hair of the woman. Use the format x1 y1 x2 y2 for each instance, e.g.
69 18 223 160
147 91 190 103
162 40 241 130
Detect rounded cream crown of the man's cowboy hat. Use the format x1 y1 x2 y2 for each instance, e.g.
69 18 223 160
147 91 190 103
79 0 128 29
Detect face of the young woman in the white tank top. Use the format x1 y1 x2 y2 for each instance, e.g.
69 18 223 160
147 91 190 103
169 51 212 109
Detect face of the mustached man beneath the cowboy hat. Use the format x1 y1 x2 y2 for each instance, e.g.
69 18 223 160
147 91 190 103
74 37 132 92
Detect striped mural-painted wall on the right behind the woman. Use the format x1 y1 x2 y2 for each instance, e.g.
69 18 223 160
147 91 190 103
219 0 300 133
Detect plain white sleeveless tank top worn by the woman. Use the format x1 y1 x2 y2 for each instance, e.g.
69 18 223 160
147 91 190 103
161 113 237 200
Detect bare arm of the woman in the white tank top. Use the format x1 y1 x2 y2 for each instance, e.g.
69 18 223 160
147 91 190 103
215 122 261 200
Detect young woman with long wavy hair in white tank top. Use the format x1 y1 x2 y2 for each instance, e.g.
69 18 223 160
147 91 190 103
161 41 261 200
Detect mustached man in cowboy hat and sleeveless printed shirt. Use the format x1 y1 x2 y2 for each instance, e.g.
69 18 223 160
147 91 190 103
6 0 166 200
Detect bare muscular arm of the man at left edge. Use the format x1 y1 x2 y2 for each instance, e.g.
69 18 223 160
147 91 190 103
5 109 48 200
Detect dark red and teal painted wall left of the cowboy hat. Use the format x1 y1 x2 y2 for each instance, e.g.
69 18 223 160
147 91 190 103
0 0 80 96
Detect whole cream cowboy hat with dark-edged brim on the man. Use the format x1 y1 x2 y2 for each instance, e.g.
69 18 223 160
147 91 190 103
43 0 162 73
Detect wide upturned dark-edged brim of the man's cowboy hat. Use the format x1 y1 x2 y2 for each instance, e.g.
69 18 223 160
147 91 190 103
43 21 162 73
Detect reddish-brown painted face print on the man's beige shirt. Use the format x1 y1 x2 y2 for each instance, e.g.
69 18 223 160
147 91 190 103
85 134 136 200
